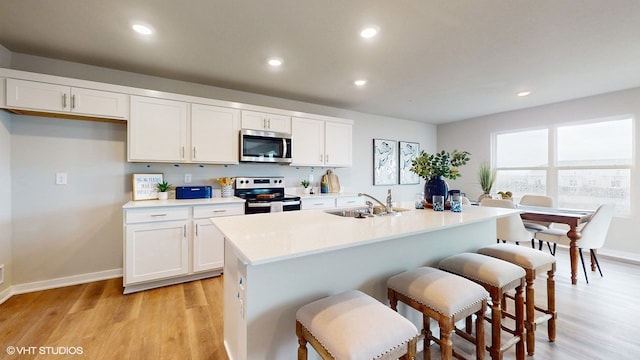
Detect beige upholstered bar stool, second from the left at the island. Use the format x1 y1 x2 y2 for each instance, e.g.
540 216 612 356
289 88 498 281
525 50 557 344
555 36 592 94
387 267 488 359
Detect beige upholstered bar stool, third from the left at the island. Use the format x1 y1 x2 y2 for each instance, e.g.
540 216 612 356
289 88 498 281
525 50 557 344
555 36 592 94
439 253 526 360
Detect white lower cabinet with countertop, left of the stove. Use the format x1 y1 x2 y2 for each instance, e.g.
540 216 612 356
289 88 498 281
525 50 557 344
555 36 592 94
124 202 244 293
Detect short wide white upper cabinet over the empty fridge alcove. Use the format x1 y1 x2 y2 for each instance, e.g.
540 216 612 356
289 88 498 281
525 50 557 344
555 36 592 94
6 79 129 119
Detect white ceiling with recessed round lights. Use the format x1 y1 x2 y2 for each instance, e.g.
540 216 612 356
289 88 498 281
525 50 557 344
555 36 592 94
0 0 640 124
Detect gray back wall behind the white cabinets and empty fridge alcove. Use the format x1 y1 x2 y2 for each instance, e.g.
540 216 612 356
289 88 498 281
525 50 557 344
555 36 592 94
0 54 436 290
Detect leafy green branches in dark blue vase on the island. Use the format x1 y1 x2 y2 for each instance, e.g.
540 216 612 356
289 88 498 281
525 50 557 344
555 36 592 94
409 150 471 203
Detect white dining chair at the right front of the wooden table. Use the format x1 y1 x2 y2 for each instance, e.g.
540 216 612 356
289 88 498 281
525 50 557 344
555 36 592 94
534 204 614 284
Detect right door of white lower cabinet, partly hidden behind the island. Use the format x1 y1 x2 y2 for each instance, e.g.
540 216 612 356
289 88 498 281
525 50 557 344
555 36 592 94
193 219 224 272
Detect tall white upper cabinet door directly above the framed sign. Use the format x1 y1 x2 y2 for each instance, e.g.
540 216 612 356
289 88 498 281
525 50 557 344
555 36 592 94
127 96 188 162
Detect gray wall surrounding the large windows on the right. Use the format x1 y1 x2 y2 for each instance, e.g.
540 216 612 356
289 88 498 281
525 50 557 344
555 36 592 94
437 88 640 259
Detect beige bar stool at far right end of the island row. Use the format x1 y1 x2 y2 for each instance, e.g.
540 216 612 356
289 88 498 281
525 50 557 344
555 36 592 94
478 244 558 356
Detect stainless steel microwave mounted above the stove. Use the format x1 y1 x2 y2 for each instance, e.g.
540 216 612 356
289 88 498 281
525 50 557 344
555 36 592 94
240 130 291 164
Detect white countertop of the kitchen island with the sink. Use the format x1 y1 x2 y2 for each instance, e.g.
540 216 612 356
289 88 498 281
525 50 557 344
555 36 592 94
211 203 520 265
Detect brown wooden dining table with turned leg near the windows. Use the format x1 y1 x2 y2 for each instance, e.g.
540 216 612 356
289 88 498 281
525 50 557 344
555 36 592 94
518 205 593 285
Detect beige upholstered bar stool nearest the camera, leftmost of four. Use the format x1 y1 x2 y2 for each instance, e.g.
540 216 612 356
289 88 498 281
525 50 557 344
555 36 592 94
296 290 419 360
